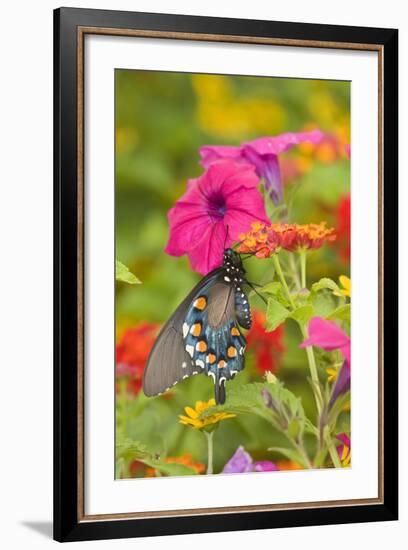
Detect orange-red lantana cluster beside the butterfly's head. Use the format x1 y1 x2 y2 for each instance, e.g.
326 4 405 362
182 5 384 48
238 222 336 258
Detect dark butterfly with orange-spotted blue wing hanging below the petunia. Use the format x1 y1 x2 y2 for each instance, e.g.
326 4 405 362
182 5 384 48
143 249 251 403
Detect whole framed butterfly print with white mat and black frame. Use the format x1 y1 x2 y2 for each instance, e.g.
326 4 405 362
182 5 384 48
54 8 398 541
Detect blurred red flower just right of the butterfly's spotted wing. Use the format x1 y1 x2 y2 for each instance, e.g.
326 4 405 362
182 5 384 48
247 311 285 374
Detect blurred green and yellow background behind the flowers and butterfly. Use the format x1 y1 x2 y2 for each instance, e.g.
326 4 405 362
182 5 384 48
115 70 350 477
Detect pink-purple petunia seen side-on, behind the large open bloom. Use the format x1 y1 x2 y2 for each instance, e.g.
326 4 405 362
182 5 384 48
200 130 323 205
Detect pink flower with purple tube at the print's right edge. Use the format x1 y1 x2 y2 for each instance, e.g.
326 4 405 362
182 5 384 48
300 317 351 407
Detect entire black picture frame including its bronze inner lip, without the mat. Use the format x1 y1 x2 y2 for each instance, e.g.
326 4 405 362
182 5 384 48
54 8 398 541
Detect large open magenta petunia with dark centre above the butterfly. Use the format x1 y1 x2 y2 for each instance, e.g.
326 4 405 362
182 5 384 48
165 160 270 275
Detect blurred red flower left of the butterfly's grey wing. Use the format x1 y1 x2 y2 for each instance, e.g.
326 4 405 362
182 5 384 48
116 322 160 395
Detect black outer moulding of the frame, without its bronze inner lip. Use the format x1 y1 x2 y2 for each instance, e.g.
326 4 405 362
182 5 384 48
54 8 398 541
